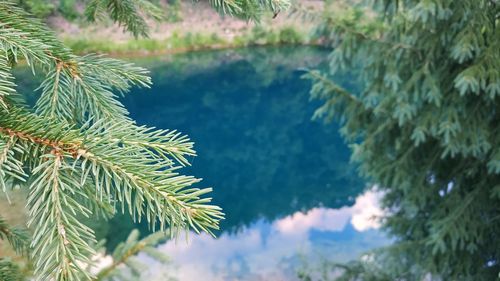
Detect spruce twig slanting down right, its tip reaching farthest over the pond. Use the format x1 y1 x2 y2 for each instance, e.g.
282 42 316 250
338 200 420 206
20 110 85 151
80 147 223 234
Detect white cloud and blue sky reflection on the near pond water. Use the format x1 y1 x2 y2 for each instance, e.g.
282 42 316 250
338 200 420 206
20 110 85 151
140 191 388 281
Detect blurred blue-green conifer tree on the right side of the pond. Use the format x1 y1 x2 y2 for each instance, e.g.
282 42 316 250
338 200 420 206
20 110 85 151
306 0 500 280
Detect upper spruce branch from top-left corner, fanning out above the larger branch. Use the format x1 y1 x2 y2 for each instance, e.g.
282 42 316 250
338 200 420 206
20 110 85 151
0 2 145 123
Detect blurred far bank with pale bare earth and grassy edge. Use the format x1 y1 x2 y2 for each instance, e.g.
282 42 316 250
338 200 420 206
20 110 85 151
46 0 324 57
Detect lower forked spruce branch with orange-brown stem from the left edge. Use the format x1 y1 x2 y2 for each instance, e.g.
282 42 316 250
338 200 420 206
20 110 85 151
0 107 223 280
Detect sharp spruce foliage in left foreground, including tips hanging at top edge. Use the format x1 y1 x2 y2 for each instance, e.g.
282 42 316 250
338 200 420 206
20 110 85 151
0 0 286 280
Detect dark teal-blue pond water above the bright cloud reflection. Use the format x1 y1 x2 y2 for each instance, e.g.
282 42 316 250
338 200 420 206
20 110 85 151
117 48 364 231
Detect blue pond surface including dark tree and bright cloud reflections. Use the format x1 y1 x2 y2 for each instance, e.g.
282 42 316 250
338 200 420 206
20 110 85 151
10 47 387 281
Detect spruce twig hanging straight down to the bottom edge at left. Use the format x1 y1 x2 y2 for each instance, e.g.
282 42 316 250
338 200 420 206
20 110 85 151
27 154 94 280
